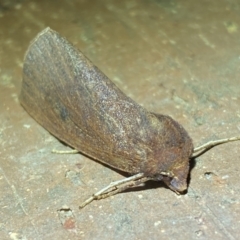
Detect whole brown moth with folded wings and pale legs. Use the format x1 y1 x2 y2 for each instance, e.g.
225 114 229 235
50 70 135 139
20 28 239 207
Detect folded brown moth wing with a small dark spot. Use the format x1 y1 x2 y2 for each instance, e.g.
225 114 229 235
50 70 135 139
20 28 152 173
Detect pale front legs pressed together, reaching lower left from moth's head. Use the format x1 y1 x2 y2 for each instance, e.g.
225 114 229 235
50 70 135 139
79 173 150 209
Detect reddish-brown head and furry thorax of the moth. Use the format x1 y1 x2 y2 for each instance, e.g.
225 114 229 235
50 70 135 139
145 113 193 193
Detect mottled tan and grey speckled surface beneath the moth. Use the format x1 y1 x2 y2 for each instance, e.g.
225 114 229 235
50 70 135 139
0 0 240 239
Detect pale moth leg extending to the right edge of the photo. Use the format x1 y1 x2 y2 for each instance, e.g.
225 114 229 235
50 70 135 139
192 136 240 158
